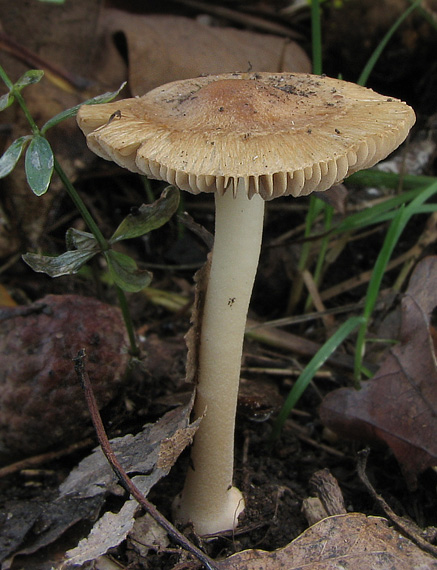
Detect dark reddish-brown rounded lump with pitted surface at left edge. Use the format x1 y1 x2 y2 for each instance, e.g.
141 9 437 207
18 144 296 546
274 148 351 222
0 295 130 460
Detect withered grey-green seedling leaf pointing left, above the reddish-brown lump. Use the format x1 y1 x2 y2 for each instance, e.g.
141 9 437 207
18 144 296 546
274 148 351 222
22 250 97 277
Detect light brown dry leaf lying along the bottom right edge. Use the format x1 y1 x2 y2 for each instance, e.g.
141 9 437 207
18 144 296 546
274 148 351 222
218 513 437 570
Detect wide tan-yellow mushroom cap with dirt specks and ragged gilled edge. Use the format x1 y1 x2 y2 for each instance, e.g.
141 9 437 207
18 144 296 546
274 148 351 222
78 73 415 200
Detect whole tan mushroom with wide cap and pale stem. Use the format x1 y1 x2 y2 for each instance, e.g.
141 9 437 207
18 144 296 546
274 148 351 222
78 73 415 535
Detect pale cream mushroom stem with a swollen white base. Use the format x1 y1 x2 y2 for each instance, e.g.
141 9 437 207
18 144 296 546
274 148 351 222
177 182 264 535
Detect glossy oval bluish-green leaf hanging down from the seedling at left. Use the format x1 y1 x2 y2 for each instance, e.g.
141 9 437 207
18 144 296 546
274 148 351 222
24 135 54 196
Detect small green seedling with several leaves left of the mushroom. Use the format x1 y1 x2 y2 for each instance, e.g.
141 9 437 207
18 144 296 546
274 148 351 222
0 67 179 354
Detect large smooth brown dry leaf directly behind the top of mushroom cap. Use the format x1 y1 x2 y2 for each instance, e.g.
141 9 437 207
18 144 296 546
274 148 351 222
102 10 311 95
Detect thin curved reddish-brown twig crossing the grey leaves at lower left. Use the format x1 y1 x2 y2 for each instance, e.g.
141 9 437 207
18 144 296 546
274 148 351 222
73 349 219 570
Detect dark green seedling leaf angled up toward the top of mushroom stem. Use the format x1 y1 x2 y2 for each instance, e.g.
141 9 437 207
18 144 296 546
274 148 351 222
109 186 179 243
